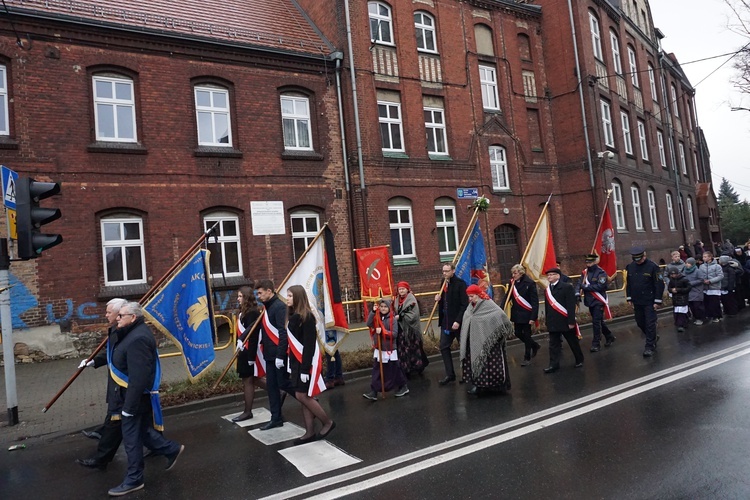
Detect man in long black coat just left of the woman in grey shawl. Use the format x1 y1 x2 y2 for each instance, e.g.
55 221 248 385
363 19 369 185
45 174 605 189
435 263 469 385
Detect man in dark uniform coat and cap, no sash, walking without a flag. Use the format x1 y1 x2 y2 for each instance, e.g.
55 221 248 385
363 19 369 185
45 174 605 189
625 246 664 358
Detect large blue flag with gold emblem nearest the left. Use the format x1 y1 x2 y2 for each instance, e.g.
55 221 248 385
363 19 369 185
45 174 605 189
143 249 216 381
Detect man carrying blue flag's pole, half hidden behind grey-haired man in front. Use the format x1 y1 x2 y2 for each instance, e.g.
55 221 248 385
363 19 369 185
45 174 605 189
76 299 127 470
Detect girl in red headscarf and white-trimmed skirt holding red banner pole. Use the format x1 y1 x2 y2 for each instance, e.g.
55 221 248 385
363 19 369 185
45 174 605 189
362 299 409 401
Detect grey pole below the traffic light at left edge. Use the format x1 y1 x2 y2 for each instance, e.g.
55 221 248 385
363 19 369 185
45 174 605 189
0 238 18 425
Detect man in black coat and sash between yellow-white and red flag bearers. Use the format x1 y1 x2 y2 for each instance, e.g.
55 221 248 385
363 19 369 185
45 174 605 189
544 267 583 373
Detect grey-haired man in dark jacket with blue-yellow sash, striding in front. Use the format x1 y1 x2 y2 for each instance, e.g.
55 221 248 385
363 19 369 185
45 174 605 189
109 302 185 496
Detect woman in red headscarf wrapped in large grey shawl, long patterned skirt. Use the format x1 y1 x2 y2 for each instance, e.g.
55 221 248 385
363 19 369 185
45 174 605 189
461 285 513 395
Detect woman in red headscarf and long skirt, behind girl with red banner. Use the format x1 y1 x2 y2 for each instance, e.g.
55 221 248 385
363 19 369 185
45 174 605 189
396 281 429 378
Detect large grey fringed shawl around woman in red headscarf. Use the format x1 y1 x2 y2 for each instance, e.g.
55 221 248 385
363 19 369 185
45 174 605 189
461 300 513 378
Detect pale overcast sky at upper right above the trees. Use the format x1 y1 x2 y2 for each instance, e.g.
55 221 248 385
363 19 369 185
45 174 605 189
649 0 750 201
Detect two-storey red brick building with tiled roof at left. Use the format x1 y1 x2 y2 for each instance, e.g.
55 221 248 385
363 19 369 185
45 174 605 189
0 0 352 348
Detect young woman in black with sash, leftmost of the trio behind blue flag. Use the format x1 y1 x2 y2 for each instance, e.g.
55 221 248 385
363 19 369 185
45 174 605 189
232 284 266 422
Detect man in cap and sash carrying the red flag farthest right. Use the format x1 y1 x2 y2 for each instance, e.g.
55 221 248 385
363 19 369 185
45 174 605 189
576 253 615 352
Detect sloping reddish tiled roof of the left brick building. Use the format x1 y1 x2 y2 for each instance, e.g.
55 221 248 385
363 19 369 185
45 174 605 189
4 0 334 56
